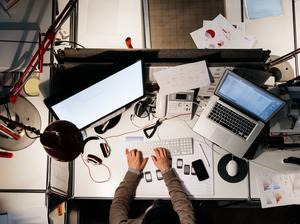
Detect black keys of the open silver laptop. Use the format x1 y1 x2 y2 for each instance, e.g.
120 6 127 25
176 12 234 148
208 103 255 139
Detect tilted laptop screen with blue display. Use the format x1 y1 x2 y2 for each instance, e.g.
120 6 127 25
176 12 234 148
216 70 285 122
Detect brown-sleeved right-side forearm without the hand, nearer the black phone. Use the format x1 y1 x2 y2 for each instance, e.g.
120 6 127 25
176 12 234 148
163 169 196 223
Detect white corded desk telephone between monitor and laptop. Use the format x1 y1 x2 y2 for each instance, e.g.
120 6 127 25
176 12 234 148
156 90 194 118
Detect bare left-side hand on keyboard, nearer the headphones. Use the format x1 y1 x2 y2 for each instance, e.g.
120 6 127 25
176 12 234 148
125 149 148 171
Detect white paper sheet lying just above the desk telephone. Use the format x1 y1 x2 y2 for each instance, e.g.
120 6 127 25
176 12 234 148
154 61 210 95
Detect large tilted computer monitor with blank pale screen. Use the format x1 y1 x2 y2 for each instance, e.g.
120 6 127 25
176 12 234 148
44 60 144 130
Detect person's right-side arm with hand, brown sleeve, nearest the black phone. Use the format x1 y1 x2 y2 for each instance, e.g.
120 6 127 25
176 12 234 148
152 148 196 224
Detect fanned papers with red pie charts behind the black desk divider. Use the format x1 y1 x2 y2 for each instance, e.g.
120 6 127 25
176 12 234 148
191 15 255 49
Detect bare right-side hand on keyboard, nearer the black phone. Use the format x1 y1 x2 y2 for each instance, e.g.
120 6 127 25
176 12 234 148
151 148 171 172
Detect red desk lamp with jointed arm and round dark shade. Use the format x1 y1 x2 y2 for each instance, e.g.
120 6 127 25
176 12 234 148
0 0 83 161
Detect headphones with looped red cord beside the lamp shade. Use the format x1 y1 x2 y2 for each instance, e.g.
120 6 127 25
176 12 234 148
81 136 111 183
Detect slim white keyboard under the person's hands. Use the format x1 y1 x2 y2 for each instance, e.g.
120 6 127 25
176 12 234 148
127 138 194 156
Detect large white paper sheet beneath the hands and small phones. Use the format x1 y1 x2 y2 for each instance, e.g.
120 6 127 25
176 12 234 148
124 136 214 197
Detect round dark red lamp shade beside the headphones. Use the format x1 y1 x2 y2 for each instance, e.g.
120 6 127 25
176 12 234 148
40 120 83 162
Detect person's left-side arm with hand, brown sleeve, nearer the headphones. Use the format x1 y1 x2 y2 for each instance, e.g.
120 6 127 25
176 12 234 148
109 149 148 224
